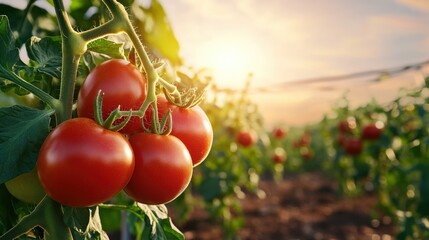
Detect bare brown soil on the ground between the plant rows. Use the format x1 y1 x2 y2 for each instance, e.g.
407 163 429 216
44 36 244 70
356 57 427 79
179 173 395 240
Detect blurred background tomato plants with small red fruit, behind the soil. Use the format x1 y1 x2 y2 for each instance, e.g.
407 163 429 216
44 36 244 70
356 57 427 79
188 74 429 239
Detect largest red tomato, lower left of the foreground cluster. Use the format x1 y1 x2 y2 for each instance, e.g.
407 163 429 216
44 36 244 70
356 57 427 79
37 118 134 207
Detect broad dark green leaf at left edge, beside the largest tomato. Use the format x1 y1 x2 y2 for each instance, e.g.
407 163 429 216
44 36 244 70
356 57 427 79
0 105 54 183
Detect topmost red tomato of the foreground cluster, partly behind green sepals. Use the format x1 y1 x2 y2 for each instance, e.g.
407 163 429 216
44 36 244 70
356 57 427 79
77 59 147 134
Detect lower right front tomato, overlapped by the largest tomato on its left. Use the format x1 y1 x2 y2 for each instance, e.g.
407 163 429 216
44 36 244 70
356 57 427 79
124 132 193 205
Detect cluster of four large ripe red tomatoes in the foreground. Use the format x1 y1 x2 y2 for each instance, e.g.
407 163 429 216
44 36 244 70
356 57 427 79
37 59 213 207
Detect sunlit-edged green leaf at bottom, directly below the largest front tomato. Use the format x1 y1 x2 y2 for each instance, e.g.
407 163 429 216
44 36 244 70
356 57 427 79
63 206 109 240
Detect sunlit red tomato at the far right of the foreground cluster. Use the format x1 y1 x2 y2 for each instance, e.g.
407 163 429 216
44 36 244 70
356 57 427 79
144 95 213 167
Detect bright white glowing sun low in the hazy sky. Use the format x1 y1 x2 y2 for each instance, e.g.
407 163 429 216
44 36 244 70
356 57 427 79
197 37 256 88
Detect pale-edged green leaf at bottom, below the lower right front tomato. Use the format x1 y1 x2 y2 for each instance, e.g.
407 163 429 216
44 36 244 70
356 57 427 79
129 203 185 240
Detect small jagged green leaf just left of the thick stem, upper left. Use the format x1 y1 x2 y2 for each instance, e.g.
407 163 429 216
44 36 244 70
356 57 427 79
25 36 62 79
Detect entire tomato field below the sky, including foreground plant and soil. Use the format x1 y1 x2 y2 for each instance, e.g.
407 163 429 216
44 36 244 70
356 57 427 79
0 0 429 240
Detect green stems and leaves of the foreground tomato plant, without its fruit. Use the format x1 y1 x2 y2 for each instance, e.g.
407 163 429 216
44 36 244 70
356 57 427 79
0 0 207 239
